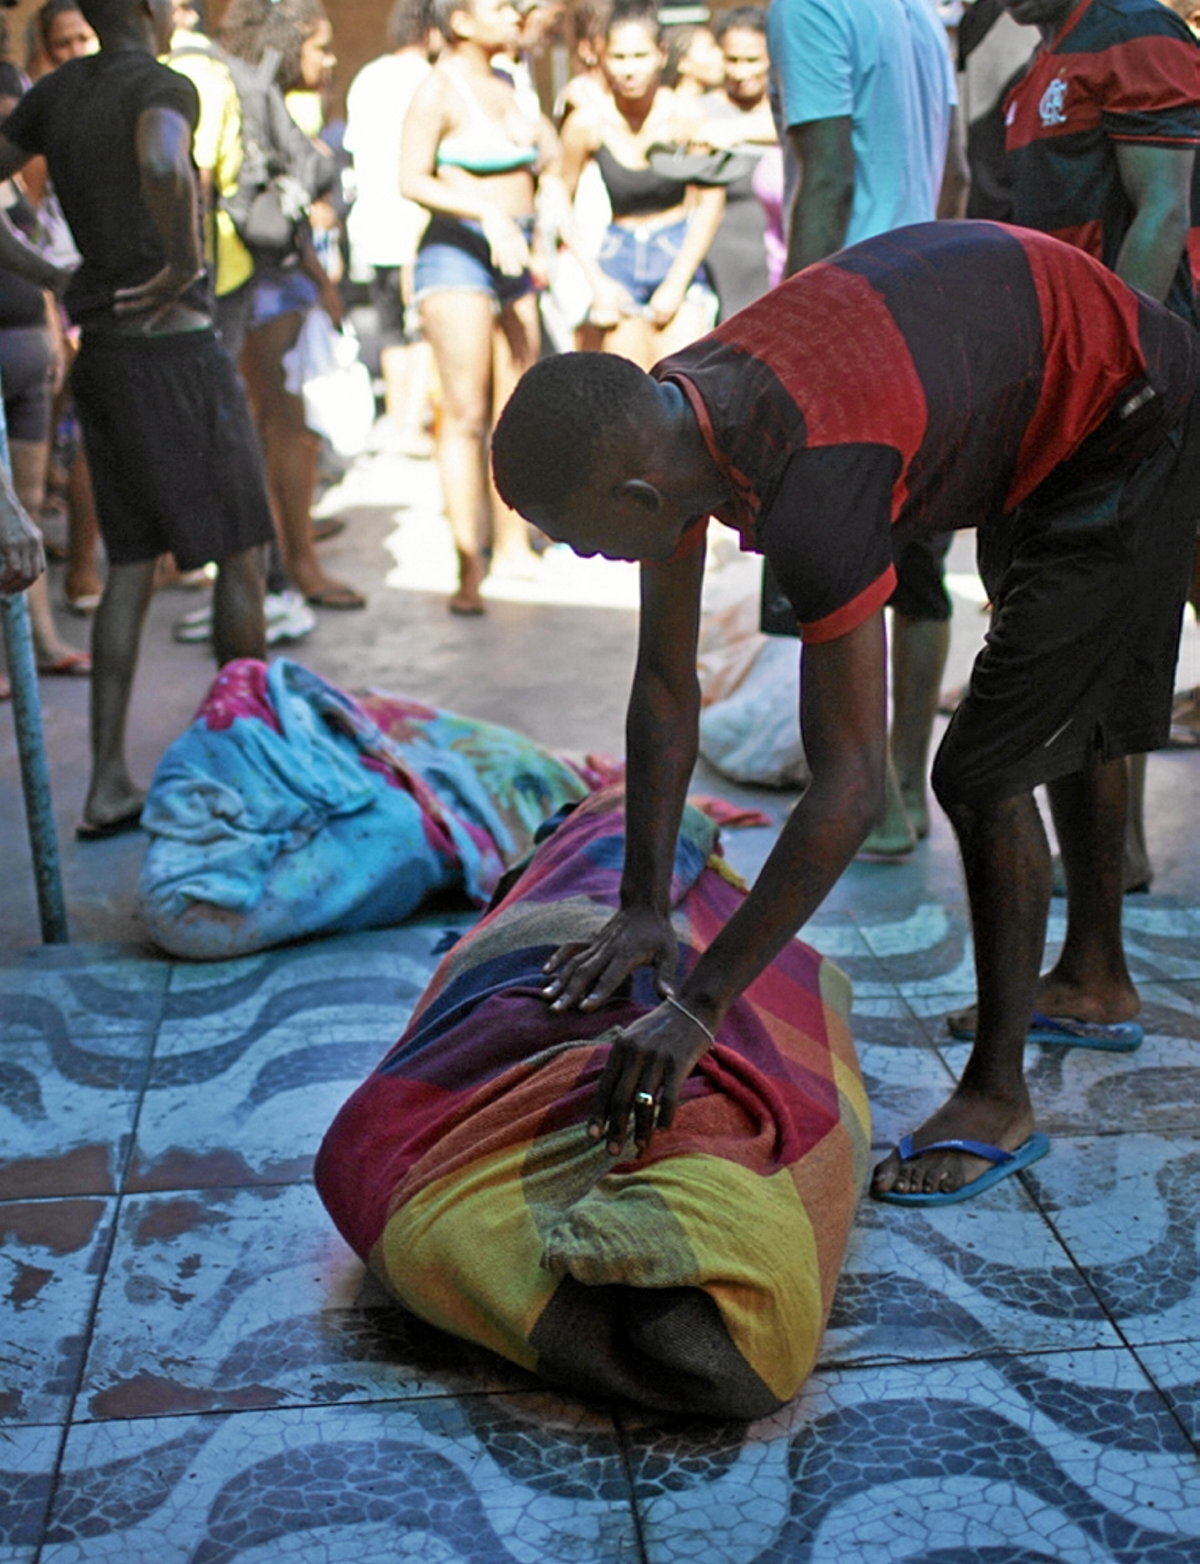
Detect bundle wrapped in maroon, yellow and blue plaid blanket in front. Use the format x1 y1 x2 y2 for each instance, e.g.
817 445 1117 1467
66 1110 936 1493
316 788 870 1417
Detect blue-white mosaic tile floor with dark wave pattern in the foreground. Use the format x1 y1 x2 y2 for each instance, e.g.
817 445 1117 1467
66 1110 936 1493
0 896 1200 1564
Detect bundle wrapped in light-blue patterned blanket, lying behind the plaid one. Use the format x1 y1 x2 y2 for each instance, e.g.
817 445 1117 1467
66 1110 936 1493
138 658 610 960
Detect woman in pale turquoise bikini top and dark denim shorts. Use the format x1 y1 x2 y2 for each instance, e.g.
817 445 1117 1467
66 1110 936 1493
401 0 559 615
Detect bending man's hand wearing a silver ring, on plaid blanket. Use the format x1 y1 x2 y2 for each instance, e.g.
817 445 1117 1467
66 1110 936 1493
588 1003 710 1157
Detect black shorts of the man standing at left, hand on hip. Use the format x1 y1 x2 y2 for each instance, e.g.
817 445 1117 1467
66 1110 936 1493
70 330 274 571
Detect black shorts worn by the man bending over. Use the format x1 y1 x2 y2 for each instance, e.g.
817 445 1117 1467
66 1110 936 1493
932 402 1200 807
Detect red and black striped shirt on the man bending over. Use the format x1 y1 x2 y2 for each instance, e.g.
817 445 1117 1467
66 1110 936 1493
654 222 1200 641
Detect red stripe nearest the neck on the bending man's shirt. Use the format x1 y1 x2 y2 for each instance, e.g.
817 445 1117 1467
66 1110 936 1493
717 261 928 519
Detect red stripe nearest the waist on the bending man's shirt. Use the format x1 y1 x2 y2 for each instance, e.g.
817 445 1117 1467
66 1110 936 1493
1006 228 1145 508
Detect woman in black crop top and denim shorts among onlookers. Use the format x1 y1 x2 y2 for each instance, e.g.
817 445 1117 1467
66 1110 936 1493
562 0 724 369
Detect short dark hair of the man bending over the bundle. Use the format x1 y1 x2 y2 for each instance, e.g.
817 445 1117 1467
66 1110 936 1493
491 353 651 516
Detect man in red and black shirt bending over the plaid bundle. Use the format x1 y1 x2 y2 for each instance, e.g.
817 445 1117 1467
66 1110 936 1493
493 222 1200 1203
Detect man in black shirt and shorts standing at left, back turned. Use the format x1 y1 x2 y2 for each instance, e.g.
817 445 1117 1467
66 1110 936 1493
0 0 272 838
